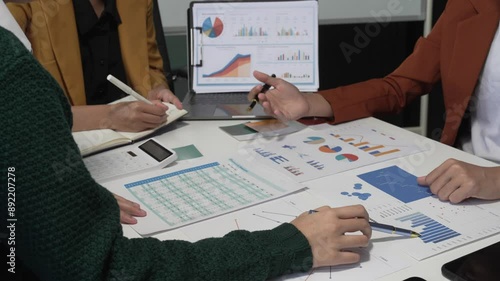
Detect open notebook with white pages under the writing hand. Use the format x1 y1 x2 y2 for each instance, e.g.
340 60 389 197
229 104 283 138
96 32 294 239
73 96 187 156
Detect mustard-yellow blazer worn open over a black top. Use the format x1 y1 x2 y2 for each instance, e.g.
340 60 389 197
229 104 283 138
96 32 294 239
7 0 167 105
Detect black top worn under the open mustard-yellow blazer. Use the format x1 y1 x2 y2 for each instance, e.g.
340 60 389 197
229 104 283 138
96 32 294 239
73 0 127 104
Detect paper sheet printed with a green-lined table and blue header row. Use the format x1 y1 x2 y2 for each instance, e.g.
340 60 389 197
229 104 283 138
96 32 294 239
104 158 303 235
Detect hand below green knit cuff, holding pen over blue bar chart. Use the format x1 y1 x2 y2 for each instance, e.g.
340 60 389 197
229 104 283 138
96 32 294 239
291 205 372 268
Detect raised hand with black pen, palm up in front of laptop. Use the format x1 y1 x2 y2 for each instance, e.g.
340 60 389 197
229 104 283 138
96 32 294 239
248 71 309 121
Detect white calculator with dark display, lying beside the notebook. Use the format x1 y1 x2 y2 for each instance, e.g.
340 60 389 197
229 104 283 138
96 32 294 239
83 139 177 182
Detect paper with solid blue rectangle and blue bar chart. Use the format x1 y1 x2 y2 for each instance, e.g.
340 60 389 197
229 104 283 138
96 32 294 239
309 166 500 260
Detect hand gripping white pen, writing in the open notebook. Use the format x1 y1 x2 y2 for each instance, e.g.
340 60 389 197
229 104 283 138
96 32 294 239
108 101 167 132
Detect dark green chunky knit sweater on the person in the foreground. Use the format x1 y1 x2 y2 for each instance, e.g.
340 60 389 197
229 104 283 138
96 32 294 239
0 28 312 281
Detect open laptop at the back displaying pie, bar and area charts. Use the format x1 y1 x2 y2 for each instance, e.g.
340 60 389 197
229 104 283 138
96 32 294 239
183 0 319 120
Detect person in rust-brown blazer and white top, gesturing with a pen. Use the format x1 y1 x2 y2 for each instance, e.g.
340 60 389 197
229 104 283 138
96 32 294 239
248 0 500 203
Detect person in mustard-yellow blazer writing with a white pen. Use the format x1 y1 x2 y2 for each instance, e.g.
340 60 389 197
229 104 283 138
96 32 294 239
8 0 182 132
